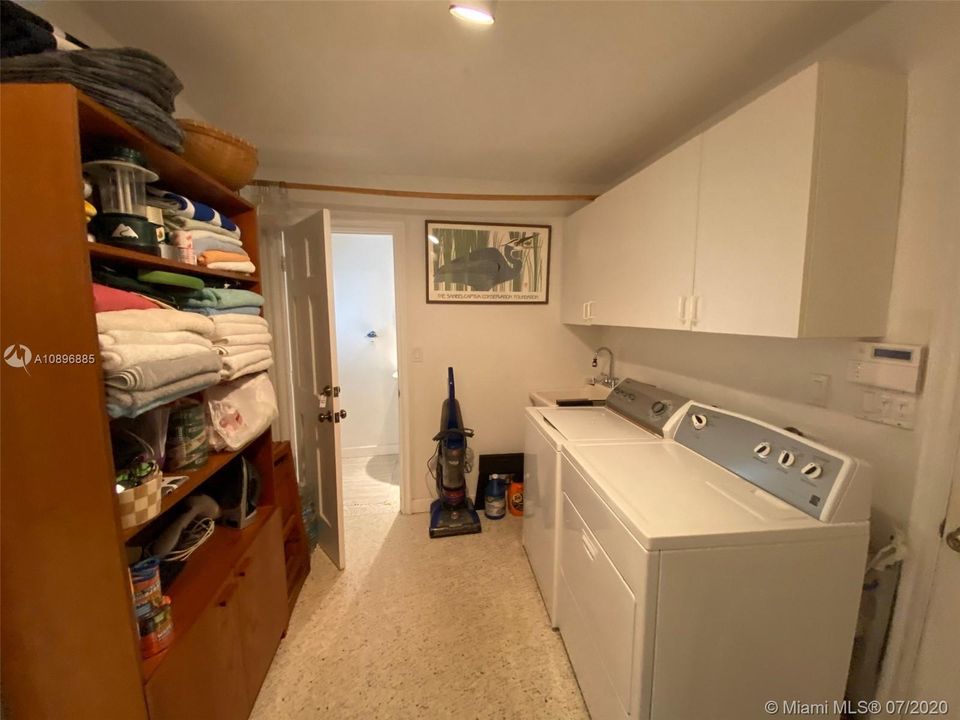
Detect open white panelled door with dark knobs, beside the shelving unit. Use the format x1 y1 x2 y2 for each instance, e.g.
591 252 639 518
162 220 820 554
283 210 346 569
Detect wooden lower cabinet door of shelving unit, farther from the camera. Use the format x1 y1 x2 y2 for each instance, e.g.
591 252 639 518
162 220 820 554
236 507 287 704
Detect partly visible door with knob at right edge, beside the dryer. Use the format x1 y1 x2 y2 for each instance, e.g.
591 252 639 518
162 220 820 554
911 442 960 718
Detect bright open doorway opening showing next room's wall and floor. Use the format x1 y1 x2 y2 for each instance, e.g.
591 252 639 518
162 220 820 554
332 232 401 516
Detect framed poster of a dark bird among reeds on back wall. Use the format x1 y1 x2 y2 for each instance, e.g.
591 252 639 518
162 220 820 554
425 220 550 305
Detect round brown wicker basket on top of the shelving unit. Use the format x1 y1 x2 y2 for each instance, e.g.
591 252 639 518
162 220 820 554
177 119 257 190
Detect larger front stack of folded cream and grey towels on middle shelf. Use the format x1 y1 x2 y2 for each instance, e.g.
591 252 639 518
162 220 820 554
97 308 224 417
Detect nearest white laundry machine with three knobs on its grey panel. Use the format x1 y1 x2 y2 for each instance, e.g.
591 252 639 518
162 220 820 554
557 403 870 720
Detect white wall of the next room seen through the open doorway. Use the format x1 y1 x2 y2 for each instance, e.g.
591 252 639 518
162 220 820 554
333 233 400 456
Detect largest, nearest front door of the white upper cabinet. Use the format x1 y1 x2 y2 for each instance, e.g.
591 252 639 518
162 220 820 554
694 66 817 337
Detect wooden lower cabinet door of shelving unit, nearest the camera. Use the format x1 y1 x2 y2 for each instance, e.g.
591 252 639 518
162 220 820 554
146 580 253 720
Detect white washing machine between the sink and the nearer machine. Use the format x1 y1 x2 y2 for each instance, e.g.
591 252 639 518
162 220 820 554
523 378 687 627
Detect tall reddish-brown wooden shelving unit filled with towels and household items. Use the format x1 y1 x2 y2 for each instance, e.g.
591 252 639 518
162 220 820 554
0 84 300 720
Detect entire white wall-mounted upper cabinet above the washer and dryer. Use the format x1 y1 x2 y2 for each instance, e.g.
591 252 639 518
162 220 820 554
564 63 906 337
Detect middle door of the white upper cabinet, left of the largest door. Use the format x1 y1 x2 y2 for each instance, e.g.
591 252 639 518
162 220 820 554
594 136 701 329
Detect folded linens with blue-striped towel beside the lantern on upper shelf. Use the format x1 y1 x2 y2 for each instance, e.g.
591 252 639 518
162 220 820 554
147 187 257 274
